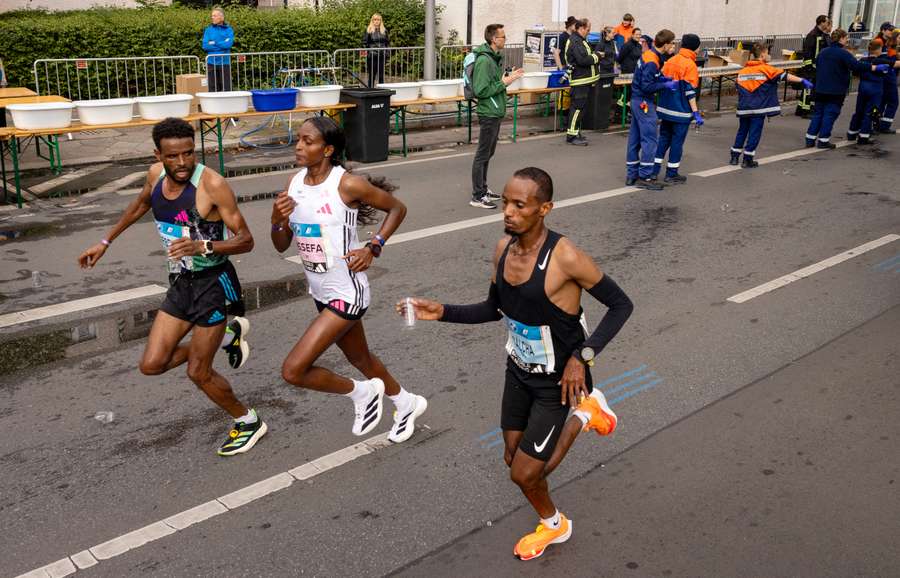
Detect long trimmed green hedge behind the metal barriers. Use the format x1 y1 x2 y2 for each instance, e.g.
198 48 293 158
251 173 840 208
0 0 425 92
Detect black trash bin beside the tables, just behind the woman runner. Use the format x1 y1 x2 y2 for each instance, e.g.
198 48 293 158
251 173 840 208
341 88 394 163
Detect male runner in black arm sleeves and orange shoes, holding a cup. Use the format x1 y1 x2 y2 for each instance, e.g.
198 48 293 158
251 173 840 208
397 167 633 560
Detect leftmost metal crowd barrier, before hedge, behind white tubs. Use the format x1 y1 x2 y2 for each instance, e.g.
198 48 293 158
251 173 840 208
33 56 202 100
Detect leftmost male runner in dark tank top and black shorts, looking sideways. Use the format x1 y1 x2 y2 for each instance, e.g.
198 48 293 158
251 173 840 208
78 118 267 456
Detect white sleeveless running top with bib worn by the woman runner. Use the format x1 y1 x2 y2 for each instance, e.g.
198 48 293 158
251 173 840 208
288 166 369 315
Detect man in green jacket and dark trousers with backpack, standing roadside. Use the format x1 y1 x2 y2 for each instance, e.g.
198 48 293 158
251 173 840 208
469 24 525 209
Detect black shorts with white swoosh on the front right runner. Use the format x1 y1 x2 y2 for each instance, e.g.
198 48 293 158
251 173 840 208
500 361 592 462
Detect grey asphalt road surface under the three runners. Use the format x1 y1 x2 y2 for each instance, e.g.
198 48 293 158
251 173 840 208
0 99 900 576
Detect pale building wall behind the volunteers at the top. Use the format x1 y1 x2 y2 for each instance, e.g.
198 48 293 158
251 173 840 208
437 0 828 43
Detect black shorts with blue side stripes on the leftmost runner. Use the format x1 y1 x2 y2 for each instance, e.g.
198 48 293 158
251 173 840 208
160 261 244 327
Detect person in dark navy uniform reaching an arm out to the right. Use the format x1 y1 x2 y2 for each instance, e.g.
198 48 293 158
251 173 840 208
806 28 891 149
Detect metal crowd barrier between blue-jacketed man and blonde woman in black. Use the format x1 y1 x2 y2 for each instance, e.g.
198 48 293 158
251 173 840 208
206 50 334 90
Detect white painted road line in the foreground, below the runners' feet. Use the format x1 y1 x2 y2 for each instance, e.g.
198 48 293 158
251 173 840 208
18 426 392 578
